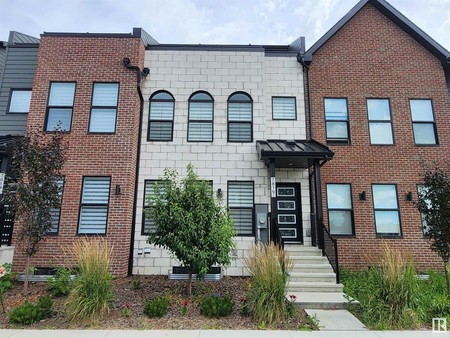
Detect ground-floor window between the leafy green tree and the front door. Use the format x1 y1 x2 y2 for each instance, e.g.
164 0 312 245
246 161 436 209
228 181 254 236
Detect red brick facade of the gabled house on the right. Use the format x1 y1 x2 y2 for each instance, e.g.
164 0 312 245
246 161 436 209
310 4 450 269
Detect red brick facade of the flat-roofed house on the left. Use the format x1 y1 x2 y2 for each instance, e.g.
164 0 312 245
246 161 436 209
13 35 145 275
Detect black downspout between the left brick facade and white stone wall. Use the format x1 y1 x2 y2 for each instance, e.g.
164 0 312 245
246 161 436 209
123 58 149 276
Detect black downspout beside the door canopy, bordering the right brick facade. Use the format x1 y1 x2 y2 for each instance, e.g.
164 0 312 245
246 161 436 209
297 54 317 246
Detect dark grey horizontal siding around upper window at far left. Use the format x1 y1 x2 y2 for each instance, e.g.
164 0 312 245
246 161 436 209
0 45 38 135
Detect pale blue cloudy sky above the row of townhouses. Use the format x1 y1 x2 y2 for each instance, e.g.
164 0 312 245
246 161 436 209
0 0 450 50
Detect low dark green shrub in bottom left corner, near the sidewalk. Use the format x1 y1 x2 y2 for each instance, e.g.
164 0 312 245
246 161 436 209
8 297 53 325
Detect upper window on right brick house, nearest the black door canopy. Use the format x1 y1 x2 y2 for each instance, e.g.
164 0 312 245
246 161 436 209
324 98 350 144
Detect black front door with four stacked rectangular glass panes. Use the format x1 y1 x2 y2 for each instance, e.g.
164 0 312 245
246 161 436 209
275 183 303 243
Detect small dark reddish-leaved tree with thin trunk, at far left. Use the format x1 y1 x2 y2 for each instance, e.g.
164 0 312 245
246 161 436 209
5 131 65 295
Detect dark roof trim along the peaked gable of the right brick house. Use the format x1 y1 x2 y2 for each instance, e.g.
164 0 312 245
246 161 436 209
303 0 450 64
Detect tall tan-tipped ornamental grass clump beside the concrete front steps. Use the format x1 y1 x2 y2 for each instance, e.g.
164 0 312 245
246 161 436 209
245 243 291 324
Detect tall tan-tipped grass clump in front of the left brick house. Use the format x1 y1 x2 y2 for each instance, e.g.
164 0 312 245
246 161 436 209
65 238 112 321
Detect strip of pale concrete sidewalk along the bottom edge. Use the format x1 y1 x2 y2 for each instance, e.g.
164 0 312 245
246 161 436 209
0 330 440 338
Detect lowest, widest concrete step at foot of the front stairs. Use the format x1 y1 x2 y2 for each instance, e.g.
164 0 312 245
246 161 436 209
286 291 359 309
